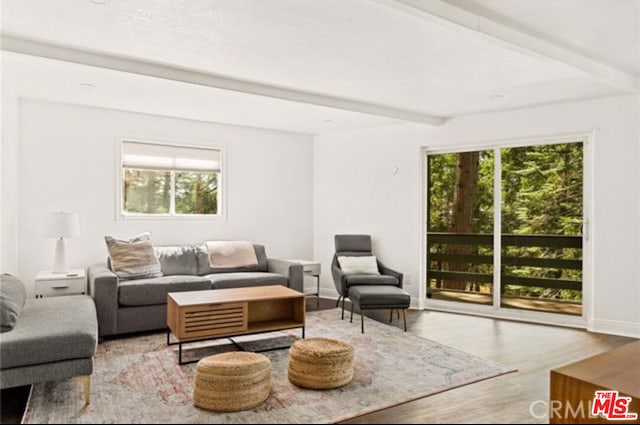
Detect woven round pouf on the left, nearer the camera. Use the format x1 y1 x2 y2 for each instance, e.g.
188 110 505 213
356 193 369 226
193 351 271 412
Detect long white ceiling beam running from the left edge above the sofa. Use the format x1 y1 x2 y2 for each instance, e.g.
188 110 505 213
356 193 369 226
0 34 446 125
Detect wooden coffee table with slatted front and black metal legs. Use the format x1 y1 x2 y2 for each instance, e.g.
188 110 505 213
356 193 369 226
167 285 305 364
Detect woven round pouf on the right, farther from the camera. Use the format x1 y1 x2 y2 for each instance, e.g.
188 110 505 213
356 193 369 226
289 338 354 390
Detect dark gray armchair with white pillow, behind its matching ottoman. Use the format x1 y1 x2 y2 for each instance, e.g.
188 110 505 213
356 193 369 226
331 235 403 319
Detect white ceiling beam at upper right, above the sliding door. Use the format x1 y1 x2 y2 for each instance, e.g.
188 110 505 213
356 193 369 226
374 0 640 93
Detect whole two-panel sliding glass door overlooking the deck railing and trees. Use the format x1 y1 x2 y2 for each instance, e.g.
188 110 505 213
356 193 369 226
425 140 584 316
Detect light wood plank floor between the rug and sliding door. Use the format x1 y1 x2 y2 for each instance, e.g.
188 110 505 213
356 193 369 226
342 303 635 423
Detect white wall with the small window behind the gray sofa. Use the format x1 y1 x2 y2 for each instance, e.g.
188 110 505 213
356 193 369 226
3 100 313 294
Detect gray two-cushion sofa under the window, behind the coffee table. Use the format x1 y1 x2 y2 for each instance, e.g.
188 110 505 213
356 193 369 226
88 244 303 336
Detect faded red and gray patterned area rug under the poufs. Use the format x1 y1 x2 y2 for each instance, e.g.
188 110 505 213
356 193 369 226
23 310 514 424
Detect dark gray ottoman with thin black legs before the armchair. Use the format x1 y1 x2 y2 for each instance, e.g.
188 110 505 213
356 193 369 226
349 285 411 333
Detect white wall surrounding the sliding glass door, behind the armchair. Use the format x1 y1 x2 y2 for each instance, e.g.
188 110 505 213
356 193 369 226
314 96 640 337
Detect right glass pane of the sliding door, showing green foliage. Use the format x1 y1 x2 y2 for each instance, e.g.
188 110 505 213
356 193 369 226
500 143 583 316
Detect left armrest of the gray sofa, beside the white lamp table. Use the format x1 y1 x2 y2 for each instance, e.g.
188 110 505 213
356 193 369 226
87 264 118 336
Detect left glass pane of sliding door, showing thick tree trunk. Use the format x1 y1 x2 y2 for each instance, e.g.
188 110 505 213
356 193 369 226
427 150 494 304
